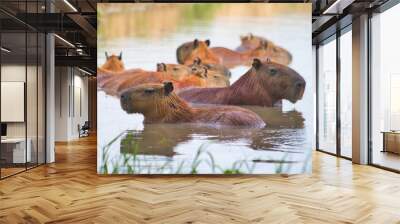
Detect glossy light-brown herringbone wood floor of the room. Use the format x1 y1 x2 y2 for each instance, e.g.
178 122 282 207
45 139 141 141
0 137 400 224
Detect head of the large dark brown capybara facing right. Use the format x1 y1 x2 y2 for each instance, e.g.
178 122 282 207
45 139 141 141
251 58 306 103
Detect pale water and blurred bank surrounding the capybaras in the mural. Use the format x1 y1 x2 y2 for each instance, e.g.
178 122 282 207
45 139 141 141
98 4 314 174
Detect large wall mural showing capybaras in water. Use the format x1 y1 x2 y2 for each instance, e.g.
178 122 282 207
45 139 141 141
97 3 314 174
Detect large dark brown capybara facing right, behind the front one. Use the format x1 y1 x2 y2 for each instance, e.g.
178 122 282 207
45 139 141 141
178 59 306 107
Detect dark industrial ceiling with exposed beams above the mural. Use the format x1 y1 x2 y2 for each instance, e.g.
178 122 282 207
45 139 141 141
0 0 393 73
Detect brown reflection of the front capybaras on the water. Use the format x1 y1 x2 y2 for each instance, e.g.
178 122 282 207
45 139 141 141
121 107 305 157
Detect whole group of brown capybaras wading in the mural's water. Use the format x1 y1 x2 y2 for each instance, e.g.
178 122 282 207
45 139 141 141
97 34 306 127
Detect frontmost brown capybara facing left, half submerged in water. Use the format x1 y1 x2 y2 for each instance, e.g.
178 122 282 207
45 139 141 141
120 82 265 128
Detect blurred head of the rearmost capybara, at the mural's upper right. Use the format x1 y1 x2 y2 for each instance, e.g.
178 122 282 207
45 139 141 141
251 40 292 65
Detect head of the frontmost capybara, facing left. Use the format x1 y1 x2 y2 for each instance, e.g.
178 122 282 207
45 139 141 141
120 81 174 116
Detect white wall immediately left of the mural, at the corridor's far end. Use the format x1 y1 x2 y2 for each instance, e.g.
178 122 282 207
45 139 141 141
55 67 88 141
